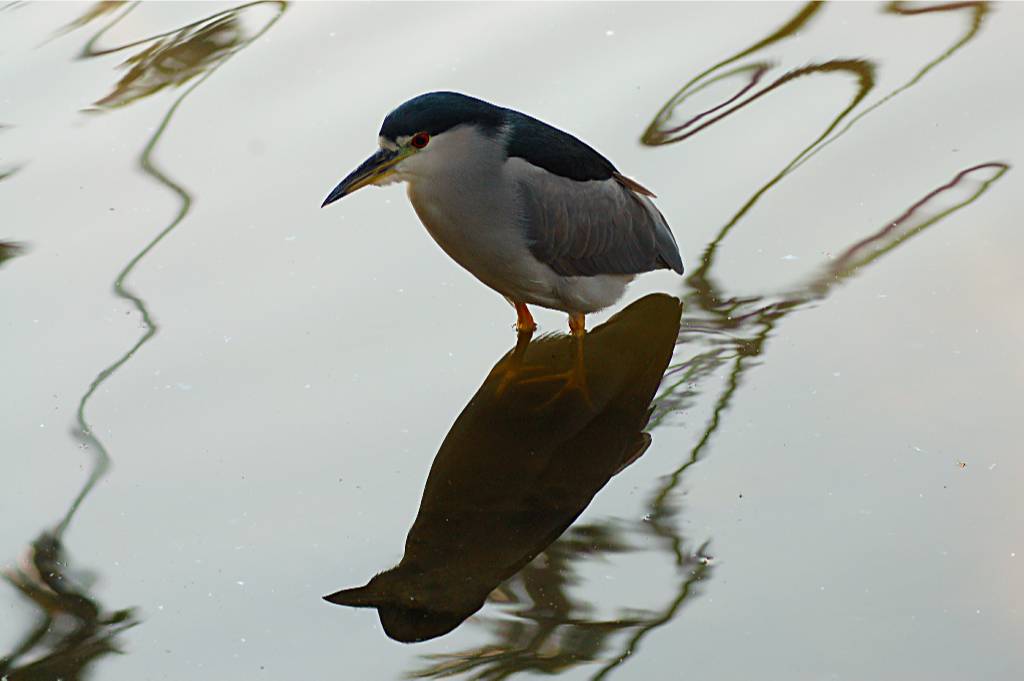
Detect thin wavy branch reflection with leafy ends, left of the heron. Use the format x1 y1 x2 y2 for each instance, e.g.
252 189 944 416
0 2 285 681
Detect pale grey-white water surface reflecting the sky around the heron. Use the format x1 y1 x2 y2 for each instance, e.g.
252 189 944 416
0 4 1024 679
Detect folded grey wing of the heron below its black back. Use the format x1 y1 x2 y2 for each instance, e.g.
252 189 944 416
509 159 683 276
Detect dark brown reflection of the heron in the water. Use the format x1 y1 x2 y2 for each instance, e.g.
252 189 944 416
327 294 681 642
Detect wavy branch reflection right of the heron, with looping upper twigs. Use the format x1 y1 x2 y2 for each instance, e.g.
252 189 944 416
409 2 1010 679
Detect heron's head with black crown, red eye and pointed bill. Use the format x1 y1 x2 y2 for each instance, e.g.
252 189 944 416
323 92 507 206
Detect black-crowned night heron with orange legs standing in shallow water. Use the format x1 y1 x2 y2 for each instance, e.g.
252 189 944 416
324 92 683 336
